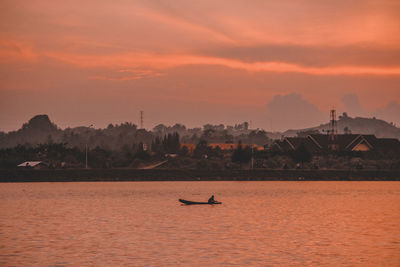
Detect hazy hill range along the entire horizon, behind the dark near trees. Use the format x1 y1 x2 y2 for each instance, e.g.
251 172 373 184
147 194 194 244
0 113 400 151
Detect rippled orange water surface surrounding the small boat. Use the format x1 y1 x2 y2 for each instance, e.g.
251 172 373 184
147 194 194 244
0 182 400 266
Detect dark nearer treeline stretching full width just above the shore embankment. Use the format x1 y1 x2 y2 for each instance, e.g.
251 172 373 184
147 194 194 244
0 137 400 170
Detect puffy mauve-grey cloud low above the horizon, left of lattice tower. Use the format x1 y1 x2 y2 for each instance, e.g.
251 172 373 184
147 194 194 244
267 93 327 131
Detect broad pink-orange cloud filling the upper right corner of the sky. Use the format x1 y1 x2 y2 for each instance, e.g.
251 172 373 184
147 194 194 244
143 0 400 47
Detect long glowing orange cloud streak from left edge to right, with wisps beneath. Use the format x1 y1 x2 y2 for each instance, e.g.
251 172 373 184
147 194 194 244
0 40 400 78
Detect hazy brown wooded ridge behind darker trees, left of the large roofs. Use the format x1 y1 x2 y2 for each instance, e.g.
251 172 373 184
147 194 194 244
0 115 271 153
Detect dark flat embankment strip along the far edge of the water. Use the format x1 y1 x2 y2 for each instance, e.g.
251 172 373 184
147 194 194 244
0 169 400 183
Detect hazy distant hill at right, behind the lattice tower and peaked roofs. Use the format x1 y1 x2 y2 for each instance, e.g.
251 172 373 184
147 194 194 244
283 113 400 139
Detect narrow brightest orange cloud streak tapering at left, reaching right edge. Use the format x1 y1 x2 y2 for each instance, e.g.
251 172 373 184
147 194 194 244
45 52 400 76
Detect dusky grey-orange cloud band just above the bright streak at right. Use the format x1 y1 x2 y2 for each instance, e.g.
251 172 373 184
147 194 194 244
205 44 400 67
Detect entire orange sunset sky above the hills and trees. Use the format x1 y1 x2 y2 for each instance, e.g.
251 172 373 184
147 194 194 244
0 0 400 131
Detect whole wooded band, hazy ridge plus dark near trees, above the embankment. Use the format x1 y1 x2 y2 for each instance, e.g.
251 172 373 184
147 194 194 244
0 115 400 170
